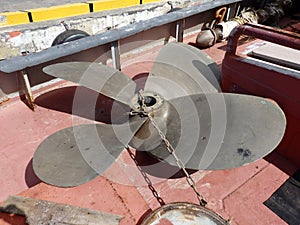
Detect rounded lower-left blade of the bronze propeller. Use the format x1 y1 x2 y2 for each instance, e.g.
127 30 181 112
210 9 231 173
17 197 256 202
33 116 146 187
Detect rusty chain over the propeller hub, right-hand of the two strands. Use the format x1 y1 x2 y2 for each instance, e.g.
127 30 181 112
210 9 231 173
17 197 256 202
139 90 207 206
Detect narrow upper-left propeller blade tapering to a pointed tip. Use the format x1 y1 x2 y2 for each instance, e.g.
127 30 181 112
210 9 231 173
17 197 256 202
43 62 136 105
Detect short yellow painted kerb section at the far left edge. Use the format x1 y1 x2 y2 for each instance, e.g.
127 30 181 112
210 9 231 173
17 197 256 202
0 12 29 27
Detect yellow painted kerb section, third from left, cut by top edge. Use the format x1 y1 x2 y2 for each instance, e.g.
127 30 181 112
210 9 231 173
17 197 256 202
89 0 140 12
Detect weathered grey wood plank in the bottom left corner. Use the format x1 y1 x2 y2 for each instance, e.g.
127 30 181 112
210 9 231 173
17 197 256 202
0 196 122 225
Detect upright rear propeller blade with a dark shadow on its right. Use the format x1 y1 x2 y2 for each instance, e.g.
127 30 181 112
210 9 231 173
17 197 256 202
145 43 220 99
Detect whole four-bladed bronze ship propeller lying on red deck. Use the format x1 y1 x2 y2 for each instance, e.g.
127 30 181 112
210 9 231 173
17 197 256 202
33 43 286 187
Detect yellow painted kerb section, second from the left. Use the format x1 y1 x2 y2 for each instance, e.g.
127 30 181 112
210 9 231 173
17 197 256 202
28 3 90 22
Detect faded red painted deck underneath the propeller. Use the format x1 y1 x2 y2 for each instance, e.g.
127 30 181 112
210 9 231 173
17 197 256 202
0 34 297 225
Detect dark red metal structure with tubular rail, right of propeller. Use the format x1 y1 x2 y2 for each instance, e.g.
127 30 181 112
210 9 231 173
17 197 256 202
222 24 300 167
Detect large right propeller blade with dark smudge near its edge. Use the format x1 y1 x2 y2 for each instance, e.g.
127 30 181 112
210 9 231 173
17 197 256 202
149 93 286 170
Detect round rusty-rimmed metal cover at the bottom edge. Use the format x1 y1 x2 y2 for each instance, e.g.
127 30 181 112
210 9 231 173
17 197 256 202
141 202 229 225
